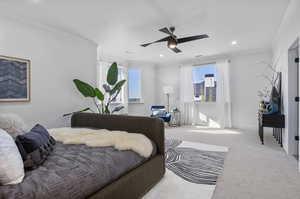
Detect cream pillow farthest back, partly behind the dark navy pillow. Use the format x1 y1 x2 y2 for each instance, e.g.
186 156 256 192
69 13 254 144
0 113 28 138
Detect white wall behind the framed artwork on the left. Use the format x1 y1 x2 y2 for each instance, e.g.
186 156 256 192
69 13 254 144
0 19 96 128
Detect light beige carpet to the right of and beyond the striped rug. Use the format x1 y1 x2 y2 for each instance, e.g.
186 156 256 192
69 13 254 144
166 127 300 199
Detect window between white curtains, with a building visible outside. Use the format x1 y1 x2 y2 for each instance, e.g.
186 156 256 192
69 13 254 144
193 65 217 102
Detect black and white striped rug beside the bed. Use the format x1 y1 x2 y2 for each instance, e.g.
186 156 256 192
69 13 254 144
143 140 228 199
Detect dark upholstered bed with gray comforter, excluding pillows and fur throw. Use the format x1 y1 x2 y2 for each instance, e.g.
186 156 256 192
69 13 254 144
0 113 165 199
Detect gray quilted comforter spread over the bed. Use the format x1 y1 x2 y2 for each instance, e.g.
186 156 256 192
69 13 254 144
0 143 145 199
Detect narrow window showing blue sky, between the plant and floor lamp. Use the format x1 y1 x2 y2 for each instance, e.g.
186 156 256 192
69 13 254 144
128 69 142 103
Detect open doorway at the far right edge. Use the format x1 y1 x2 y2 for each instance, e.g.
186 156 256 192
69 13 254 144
288 39 300 161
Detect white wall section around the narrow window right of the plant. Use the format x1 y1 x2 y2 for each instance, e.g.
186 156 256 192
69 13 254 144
128 61 157 116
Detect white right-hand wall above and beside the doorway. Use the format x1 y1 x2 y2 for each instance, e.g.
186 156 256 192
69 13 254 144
273 0 300 154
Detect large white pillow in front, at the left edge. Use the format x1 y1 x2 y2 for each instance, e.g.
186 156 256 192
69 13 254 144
0 129 24 185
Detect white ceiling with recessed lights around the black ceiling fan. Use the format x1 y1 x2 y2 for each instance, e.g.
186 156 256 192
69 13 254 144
0 0 289 62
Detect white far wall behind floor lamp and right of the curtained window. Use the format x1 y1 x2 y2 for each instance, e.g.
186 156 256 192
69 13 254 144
156 51 272 131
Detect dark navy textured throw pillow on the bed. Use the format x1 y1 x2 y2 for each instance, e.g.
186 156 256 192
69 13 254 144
16 124 56 169
